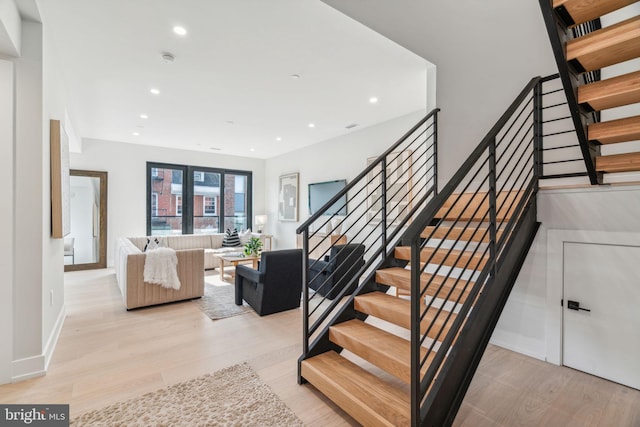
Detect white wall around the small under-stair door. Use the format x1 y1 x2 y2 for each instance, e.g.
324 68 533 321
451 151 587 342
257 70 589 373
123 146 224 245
492 186 640 361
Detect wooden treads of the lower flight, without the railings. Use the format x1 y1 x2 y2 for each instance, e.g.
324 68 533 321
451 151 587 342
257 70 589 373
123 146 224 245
301 192 518 426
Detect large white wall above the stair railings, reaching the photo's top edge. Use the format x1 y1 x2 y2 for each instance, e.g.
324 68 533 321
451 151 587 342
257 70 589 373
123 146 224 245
323 0 557 185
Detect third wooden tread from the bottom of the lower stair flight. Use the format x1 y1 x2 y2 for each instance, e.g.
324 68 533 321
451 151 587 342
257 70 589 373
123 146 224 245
355 292 456 340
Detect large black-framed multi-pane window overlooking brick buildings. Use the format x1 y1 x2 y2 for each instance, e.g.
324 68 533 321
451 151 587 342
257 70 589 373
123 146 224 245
147 162 252 236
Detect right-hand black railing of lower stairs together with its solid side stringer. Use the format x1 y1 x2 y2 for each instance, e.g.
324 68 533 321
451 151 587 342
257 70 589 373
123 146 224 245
401 77 542 425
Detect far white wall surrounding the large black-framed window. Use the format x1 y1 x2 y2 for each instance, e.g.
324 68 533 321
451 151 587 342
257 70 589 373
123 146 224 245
70 139 265 266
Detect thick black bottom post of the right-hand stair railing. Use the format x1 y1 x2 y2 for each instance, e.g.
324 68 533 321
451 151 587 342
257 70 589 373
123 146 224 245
411 238 422 426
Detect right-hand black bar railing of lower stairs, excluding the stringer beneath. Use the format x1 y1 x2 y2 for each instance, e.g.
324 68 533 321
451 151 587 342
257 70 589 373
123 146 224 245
402 78 541 425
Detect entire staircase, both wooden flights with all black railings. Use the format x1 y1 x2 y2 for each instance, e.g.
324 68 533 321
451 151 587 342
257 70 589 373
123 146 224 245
297 0 640 426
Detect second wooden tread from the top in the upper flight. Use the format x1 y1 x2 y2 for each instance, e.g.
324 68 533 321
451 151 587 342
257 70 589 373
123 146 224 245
567 16 640 71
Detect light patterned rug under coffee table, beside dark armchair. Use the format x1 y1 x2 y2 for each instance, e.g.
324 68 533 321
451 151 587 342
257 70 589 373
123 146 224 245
194 276 253 320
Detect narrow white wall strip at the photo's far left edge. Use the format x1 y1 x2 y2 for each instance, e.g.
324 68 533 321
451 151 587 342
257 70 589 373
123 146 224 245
0 59 15 384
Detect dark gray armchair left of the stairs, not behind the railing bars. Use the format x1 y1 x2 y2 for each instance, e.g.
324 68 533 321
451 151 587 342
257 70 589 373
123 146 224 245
235 249 302 316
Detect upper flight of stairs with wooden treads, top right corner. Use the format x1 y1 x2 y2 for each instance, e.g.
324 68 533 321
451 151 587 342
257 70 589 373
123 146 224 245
540 0 640 184
